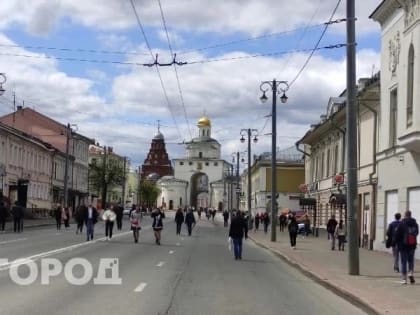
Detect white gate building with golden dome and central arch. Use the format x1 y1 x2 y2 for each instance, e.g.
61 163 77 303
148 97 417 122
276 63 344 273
157 117 231 210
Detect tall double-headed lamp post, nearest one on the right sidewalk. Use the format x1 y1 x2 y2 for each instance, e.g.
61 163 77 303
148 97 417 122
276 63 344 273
260 79 289 242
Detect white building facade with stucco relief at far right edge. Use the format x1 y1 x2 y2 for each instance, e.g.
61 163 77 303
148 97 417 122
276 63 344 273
371 0 420 258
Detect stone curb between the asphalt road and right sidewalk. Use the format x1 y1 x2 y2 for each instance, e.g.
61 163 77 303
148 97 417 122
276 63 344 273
249 236 383 315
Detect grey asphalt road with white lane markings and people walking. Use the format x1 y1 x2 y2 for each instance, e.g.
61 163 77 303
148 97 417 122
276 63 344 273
0 215 364 315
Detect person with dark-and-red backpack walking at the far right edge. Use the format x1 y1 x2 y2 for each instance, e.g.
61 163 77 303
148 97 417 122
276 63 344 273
396 210 419 284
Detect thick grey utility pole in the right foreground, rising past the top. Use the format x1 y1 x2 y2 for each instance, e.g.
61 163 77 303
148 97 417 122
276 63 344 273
346 0 359 275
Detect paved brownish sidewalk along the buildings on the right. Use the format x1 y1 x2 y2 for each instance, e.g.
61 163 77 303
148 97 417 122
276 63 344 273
249 230 420 315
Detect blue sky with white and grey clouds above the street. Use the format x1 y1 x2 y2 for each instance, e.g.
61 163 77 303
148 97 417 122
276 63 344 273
0 0 381 166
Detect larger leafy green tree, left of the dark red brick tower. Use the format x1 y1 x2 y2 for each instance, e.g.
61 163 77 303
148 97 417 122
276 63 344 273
89 156 125 208
